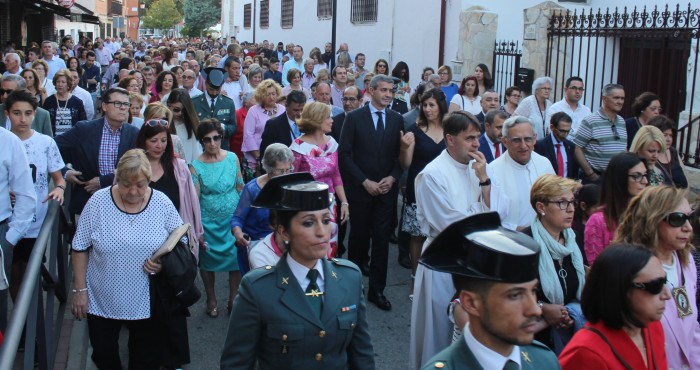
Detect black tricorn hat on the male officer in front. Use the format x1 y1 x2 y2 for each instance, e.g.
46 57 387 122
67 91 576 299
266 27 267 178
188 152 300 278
420 212 540 284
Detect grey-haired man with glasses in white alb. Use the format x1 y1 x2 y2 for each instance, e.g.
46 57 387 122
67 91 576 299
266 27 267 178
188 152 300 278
486 116 556 231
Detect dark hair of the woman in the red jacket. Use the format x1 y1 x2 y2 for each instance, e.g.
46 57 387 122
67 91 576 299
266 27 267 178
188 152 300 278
581 244 653 329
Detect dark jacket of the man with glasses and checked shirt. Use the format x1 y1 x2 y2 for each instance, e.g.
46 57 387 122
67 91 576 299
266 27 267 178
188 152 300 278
55 118 139 214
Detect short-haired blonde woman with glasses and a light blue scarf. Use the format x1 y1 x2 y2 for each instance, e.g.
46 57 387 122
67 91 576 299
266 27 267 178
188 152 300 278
523 174 586 354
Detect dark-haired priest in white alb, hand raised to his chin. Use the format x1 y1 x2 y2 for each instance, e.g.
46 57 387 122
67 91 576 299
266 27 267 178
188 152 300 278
409 111 507 370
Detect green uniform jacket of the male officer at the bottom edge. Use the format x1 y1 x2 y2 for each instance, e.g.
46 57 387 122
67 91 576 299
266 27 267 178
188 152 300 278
421 336 561 370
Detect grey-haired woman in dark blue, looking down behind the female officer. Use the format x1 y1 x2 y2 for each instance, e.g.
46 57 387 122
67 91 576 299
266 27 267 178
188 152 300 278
231 143 294 275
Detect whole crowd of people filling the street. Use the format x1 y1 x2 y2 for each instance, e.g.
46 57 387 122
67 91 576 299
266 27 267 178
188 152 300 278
0 33 700 370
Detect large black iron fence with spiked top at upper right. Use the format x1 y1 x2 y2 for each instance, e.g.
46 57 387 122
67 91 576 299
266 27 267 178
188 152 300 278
545 4 700 167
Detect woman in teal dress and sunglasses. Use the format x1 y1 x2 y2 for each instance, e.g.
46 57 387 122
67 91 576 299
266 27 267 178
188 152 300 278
192 119 244 318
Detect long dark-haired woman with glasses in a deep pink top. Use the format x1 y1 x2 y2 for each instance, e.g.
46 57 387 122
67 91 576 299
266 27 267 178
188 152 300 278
583 153 649 265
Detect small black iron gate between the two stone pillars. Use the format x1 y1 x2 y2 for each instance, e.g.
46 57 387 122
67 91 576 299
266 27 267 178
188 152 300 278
491 41 523 104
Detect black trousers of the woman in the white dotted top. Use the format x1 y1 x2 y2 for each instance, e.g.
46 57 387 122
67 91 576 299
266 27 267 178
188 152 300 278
88 314 159 370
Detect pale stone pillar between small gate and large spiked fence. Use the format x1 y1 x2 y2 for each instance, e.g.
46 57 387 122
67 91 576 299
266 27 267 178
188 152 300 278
520 1 566 91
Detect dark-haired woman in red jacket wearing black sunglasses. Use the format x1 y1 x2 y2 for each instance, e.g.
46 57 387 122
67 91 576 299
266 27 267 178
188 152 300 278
559 244 672 370
